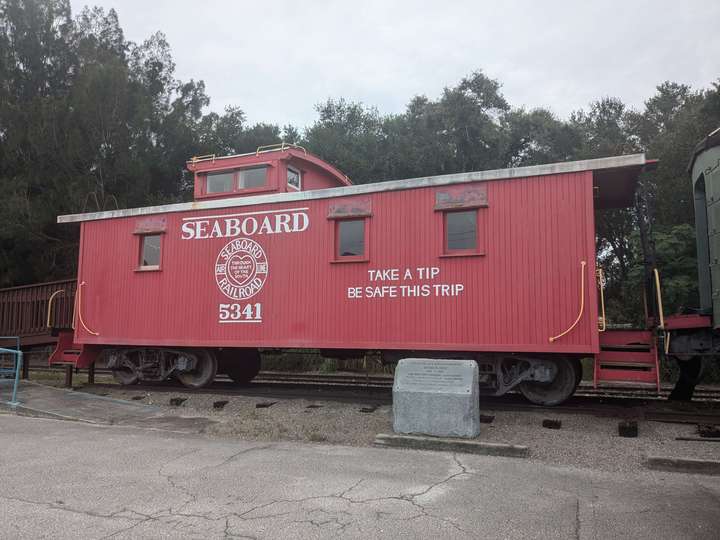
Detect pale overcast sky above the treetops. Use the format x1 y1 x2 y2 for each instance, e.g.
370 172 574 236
72 0 720 127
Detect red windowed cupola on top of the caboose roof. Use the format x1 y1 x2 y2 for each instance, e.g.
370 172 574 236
187 143 351 200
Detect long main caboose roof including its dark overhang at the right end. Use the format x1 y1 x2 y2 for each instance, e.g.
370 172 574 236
57 154 657 223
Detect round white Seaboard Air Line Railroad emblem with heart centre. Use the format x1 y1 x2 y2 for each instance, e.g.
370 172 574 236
215 238 268 300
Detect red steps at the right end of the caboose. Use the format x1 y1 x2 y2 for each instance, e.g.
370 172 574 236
593 330 660 393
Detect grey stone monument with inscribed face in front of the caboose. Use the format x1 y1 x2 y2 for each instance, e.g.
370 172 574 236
393 358 480 438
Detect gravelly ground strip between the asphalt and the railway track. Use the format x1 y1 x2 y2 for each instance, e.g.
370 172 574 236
25 373 720 472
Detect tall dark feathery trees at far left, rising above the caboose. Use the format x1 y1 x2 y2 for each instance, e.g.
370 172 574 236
0 0 219 285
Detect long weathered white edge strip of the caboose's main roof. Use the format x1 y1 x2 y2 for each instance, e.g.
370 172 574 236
57 154 646 223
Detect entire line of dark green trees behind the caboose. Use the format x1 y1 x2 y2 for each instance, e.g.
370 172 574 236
0 0 720 310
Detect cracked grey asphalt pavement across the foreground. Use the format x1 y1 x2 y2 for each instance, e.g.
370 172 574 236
0 414 720 539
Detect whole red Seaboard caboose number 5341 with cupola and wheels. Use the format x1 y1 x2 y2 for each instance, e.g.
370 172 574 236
51 145 657 403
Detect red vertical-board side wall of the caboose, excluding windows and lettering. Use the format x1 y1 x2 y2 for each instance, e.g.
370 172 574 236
76 171 598 353
